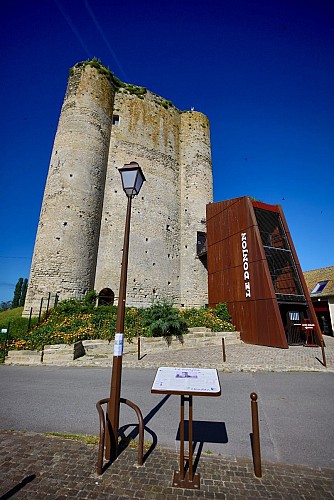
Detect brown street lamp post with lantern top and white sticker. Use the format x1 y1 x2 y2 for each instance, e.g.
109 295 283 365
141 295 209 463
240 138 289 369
105 162 145 461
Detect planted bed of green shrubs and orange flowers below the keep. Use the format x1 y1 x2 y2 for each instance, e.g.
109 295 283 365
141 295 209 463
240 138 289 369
5 292 235 350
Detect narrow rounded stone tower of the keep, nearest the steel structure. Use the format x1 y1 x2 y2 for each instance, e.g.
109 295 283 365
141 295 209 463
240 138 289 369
180 112 213 306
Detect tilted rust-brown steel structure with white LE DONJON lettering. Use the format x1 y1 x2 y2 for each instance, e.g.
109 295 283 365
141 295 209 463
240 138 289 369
207 196 322 348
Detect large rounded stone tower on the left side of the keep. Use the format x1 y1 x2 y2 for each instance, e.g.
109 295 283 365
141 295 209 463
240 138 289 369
23 63 114 315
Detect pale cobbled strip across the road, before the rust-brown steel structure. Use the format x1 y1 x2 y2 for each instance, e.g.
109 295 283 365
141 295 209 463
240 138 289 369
71 337 334 372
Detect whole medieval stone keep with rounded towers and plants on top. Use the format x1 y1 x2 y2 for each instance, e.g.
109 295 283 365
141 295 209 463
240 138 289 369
24 62 212 315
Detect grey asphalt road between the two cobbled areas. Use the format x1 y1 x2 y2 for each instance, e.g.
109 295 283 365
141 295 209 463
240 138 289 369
0 366 334 468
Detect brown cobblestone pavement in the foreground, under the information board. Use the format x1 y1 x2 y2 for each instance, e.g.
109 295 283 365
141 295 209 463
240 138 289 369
0 431 334 500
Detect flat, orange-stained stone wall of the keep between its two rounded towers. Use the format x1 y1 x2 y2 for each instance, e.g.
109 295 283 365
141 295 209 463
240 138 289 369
95 92 180 306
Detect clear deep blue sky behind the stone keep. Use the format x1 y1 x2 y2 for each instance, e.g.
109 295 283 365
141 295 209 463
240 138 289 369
0 0 334 302
